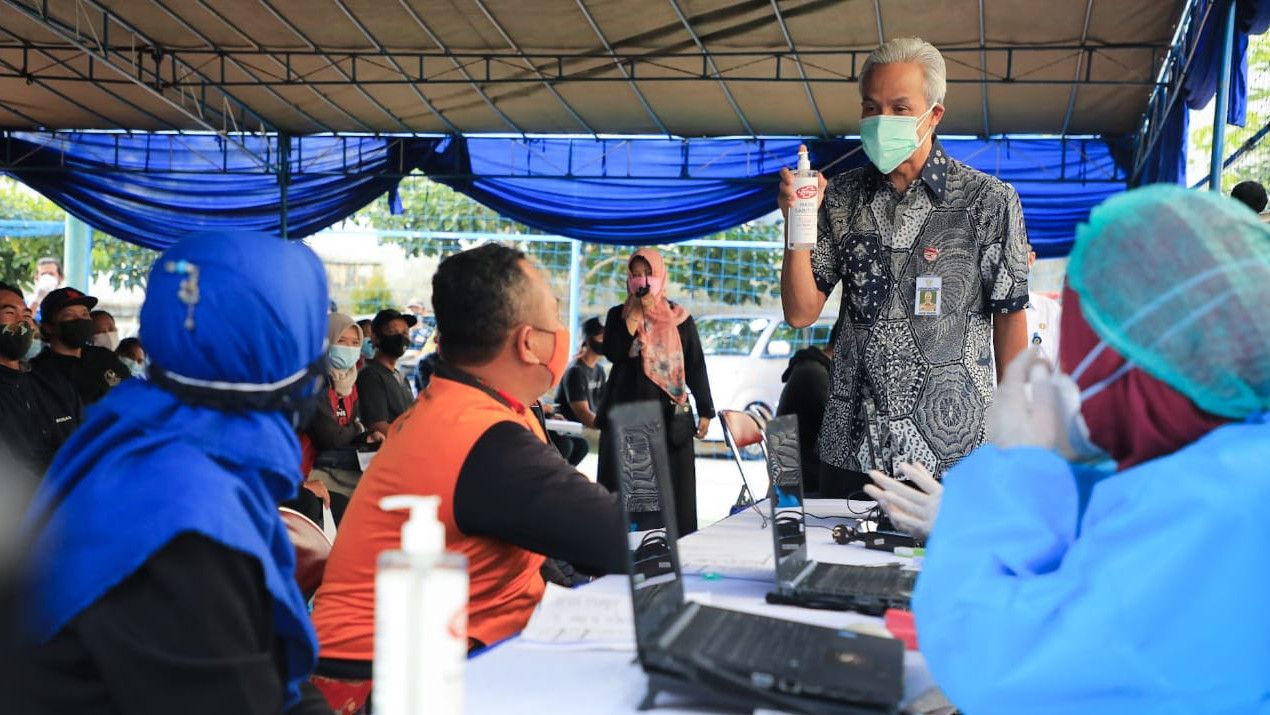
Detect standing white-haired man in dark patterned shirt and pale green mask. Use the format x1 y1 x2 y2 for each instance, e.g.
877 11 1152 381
777 38 1029 497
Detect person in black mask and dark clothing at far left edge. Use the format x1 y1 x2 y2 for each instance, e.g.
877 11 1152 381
0 283 81 476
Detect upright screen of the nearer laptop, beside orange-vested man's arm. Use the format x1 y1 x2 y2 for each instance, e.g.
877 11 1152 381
603 403 683 658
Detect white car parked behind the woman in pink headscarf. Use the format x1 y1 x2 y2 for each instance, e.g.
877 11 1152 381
696 314 833 441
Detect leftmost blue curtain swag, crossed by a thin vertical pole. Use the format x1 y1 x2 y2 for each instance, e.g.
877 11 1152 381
5 132 439 249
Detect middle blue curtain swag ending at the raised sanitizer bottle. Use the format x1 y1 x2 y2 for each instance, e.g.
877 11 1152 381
422 137 799 244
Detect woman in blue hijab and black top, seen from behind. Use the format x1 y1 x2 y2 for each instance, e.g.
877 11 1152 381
10 234 329 715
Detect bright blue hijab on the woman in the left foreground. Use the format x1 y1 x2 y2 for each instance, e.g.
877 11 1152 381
27 234 328 707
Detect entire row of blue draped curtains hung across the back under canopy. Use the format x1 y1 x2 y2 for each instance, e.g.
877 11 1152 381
6 132 1125 255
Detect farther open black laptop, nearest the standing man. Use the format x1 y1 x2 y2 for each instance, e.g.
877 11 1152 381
765 415 917 616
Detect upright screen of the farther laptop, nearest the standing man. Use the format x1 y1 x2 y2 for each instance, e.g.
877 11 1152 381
765 414 806 583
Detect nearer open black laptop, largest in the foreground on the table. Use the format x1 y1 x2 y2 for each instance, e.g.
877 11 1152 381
605 403 904 715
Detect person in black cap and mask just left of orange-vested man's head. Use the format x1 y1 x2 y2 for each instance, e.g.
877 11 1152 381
357 309 418 437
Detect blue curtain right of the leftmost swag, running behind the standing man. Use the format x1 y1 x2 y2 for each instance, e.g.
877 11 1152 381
422 137 1125 257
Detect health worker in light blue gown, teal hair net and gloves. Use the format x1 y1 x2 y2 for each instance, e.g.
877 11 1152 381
875 184 1270 715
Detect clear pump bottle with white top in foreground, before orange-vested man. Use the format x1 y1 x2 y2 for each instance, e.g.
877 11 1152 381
372 495 467 715
